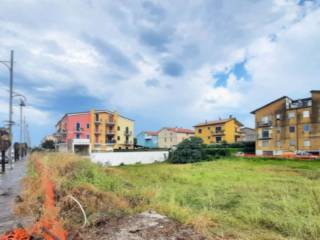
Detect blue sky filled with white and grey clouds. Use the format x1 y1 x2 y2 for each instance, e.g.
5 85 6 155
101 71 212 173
0 0 320 145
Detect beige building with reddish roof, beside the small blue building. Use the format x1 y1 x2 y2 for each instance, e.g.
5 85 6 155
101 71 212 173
158 128 194 148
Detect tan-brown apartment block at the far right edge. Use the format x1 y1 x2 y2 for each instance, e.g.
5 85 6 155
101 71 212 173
251 90 320 155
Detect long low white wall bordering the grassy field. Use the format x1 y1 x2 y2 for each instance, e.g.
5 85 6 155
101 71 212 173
90 151 169 166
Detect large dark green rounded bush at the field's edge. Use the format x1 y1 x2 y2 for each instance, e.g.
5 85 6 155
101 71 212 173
169 137 206 163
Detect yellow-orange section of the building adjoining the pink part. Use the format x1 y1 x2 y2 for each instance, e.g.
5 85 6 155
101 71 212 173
90 110 134 151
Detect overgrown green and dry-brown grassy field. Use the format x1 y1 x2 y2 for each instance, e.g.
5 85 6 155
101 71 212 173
21 154 320 240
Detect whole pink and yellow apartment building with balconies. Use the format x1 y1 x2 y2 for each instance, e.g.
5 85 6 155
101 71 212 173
55 110 134 153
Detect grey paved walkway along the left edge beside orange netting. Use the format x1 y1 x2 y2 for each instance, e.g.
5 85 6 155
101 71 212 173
0 160 27 233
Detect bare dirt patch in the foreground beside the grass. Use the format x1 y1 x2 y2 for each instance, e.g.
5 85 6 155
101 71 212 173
75 211 210 240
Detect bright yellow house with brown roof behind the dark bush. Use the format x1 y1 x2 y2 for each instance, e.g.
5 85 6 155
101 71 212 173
194 116 243 144
